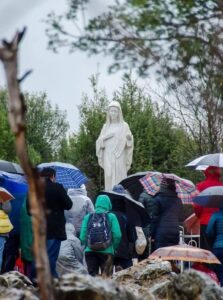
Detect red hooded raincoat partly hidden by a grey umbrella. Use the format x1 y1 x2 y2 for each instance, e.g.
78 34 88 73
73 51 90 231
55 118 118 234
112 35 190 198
194 166 223 225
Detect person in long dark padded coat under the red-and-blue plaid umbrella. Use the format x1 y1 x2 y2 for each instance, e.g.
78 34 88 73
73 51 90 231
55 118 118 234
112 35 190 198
151 179 183 250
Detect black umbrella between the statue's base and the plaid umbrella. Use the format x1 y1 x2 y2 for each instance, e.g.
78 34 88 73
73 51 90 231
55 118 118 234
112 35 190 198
119 171 148 200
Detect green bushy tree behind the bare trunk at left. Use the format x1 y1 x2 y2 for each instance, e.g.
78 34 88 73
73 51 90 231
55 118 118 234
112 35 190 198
0 88 68 164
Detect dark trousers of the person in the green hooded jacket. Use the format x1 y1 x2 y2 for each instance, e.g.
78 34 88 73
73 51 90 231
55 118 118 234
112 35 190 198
85 252 113 277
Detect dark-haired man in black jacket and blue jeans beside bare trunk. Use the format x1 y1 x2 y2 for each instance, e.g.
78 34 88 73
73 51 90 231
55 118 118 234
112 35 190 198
40 168 73 277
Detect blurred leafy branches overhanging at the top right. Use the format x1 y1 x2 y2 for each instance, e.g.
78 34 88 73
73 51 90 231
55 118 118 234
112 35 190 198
46 0 223 84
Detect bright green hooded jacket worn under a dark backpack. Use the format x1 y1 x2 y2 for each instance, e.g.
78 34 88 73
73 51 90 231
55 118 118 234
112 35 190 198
80 195 122 255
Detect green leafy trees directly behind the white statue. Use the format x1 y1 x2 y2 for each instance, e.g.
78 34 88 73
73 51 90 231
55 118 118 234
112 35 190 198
63 77 199 192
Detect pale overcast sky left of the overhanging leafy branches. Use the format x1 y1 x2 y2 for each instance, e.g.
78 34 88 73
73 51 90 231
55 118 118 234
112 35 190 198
0 0 158 131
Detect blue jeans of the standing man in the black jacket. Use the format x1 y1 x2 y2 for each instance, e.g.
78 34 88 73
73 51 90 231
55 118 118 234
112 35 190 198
46 239 61 277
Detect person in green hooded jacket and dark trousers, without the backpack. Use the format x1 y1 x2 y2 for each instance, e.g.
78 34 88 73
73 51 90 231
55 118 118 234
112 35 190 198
80 195 122 276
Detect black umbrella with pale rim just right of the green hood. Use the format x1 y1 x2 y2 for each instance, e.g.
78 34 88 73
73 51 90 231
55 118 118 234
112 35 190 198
99 191 150 227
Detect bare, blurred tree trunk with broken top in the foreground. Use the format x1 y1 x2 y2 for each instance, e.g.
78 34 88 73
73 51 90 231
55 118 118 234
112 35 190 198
0 29 54 300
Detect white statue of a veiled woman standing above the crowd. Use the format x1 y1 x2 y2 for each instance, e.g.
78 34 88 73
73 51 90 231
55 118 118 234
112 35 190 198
96 101 134 190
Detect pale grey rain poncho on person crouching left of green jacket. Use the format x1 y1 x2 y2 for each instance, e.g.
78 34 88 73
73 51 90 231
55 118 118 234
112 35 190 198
56 223 87 276
